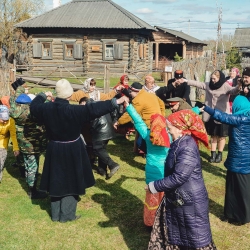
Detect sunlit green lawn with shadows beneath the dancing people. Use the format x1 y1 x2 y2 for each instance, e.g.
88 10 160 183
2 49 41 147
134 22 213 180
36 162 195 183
0 133 250 250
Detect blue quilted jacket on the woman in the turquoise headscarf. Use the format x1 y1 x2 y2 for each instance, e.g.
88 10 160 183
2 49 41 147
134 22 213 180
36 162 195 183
204 106 250 174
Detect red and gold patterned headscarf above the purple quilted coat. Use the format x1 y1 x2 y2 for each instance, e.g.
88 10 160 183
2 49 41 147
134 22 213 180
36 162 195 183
167 109 209 147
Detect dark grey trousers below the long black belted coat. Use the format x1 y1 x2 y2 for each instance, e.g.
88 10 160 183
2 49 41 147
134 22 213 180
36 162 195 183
50 195 79 222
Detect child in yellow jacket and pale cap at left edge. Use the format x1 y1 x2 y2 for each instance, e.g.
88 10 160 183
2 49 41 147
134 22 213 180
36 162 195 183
0 105 19 182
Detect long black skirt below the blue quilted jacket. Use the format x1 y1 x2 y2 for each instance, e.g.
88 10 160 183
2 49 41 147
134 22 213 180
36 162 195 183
224 170 250 224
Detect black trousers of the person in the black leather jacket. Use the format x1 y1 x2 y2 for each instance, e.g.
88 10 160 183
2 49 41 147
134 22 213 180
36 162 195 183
93 140 118 170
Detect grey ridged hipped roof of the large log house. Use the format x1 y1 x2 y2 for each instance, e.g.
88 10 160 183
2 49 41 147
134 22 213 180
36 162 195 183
15 0 155 30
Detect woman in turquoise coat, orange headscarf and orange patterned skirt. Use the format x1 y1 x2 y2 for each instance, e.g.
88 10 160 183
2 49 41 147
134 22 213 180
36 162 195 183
126 103 170 226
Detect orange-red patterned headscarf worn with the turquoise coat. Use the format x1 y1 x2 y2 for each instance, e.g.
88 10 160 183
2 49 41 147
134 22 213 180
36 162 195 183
150 114 170 148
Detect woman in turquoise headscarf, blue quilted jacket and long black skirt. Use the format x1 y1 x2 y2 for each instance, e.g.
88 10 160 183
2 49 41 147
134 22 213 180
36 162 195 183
204 96 250 224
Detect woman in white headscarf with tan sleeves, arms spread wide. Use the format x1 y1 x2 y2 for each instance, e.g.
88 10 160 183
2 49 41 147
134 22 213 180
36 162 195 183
70 78 123 102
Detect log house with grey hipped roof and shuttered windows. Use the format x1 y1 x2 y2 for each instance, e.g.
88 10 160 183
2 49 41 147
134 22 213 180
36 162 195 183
16 0 155 75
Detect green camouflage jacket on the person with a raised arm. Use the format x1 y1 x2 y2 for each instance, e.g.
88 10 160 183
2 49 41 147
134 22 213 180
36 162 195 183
10 86 47 154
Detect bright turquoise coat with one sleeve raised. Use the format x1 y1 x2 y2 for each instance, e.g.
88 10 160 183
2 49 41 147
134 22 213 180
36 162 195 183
126 104 170 184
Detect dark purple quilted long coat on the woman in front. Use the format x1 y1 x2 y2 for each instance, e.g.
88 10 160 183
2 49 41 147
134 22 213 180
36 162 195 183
154 135 212 248
